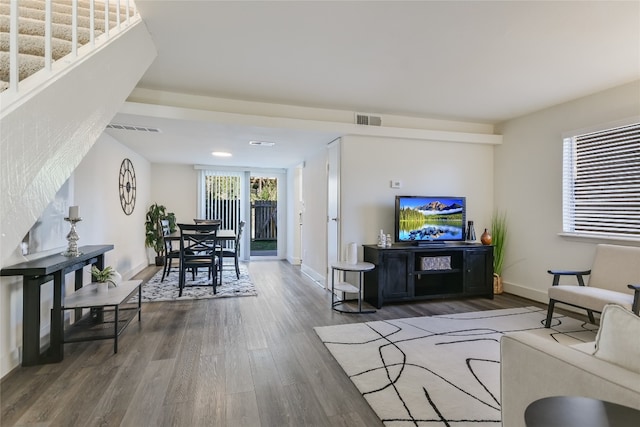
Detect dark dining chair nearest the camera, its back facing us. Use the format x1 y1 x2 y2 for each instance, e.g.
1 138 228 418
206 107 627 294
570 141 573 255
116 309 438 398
178 224 220 296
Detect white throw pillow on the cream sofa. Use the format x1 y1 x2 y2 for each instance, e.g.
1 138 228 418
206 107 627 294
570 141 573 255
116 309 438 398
593 304 640 374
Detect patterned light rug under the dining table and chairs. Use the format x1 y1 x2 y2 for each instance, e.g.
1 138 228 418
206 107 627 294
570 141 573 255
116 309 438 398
136 264 258 302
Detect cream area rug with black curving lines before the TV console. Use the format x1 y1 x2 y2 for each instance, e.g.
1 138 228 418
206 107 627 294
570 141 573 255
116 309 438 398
315 307 597 427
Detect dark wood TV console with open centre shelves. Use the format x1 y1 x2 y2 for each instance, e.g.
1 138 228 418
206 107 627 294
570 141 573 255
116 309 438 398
364 243 493 308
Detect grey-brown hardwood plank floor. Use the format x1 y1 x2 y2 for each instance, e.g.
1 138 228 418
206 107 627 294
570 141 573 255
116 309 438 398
0 261 544 427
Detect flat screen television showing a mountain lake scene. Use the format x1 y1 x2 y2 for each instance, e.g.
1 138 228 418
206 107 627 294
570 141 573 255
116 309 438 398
395 196 466 244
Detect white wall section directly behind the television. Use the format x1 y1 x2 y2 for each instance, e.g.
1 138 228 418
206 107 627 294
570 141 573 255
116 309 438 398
340 136 494 259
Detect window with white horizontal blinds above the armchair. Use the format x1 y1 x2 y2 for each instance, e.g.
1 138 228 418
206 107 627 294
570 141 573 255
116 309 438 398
562 123 640 238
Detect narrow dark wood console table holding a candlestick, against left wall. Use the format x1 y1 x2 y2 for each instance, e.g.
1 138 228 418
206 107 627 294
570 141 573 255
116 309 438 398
0 245 113 366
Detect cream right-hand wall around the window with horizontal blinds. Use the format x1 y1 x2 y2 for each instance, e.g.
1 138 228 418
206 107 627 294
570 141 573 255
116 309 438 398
494 81 640 302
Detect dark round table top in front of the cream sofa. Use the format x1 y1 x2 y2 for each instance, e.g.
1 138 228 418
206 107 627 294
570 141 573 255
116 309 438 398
524 396 640 427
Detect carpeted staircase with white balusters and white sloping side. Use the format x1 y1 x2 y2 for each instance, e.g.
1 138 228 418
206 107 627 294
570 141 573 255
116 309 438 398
0 0 156 265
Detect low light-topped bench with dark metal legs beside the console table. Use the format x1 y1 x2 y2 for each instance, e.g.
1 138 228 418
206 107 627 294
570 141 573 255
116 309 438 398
62 280 142 353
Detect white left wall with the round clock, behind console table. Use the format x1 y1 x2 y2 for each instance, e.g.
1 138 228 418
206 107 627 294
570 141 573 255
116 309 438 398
0 134 150 376
